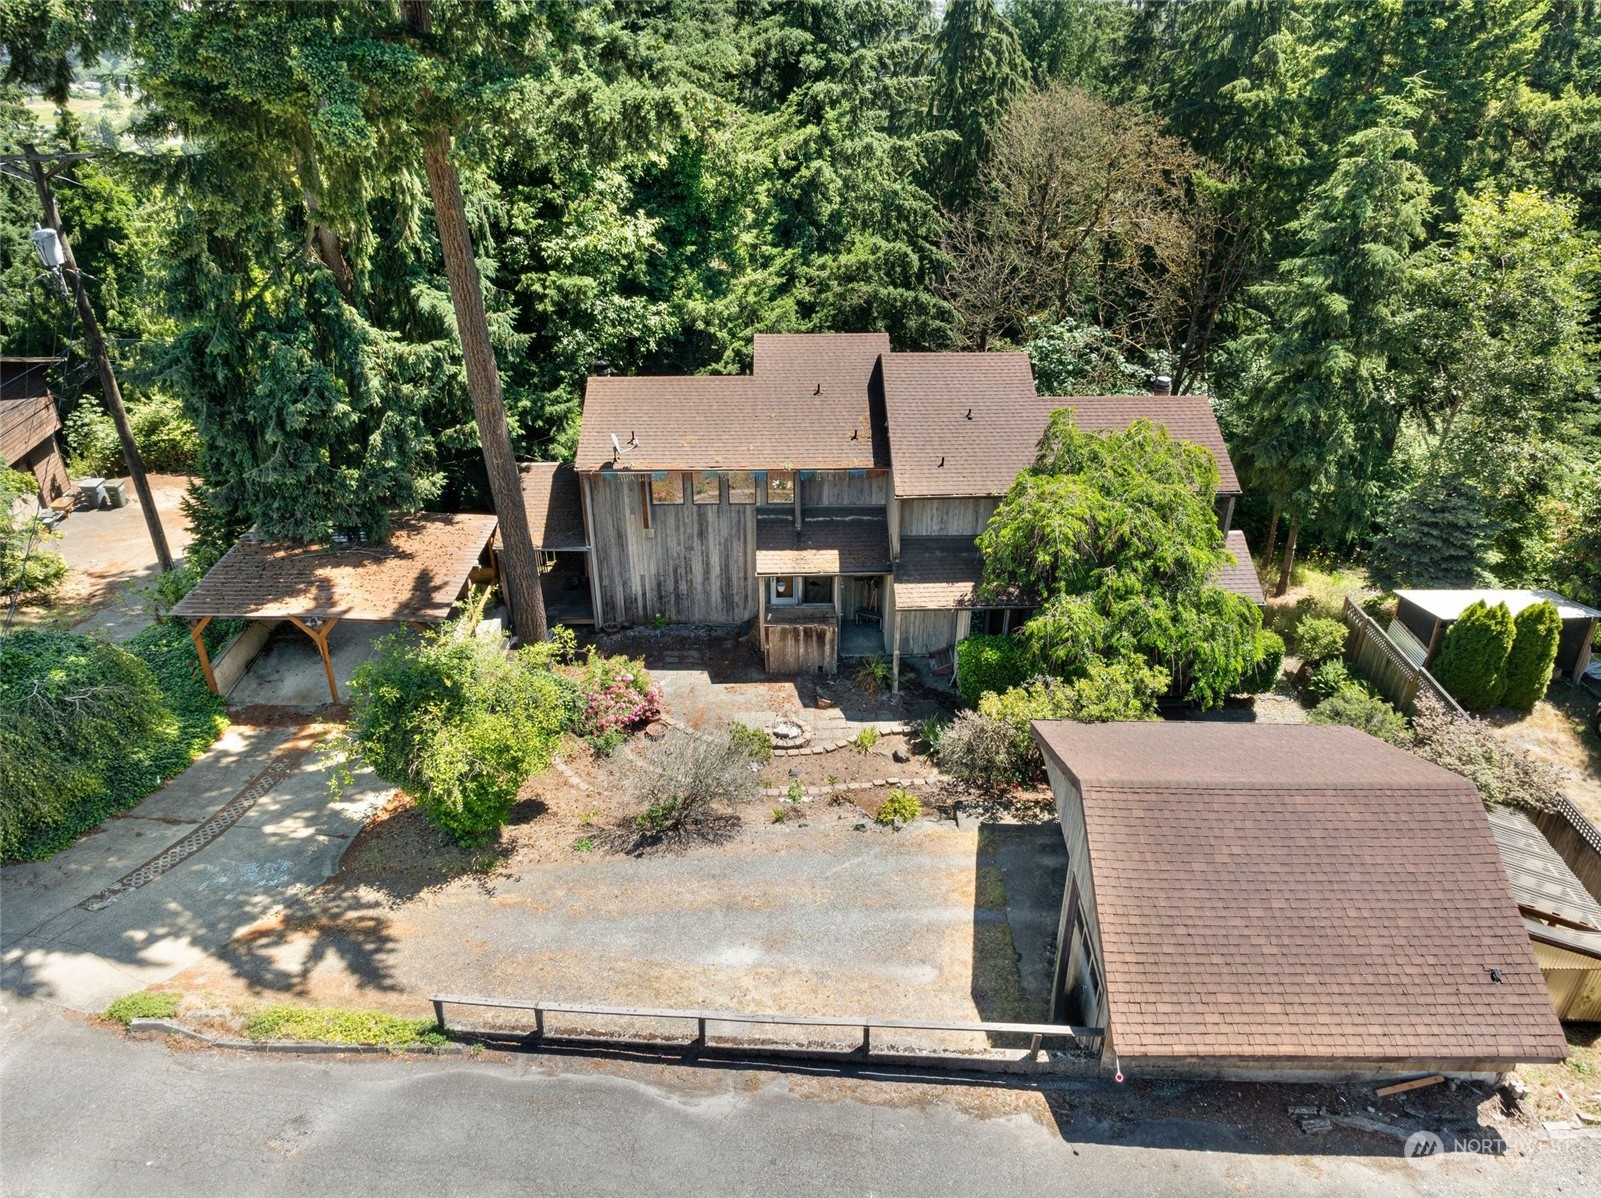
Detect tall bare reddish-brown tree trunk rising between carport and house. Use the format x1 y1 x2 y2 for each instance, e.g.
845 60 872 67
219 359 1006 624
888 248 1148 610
402 0 549 645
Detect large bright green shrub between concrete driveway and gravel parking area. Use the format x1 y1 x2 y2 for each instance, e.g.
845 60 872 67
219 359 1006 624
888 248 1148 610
346 620 583 844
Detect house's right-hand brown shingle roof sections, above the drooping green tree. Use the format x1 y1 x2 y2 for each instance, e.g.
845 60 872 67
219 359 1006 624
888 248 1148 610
884 354 1239 498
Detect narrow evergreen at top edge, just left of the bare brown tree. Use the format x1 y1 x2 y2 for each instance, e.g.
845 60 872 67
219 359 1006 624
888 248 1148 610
929 0 1028 207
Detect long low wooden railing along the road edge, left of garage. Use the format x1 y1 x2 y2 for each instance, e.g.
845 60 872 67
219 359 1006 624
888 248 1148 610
431 995 1103 1060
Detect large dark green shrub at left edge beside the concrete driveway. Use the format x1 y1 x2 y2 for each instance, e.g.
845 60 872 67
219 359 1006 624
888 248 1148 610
0 621 228 860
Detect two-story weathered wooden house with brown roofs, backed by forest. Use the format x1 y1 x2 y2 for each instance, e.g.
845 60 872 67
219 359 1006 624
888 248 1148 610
541 333 1262 673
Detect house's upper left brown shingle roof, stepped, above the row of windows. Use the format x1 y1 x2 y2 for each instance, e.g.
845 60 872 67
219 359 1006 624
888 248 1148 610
575 333 890 471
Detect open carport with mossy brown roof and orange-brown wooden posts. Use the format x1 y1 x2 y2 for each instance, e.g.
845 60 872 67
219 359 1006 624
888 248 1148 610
171 513 496 703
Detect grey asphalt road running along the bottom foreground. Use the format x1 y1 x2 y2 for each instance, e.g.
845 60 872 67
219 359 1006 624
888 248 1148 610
0 1004 1601 1198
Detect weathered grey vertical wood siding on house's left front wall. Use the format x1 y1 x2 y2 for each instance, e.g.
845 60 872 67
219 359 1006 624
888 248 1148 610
586 472 757 623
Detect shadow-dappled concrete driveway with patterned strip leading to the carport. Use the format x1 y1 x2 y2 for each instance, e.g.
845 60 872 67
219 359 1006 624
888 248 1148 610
0 726 392 1011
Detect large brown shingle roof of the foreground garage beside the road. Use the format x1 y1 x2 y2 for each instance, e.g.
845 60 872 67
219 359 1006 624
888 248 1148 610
1034 722 1567 1062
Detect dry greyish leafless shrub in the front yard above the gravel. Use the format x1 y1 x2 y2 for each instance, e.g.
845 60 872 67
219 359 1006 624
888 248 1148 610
604 734 759 855
